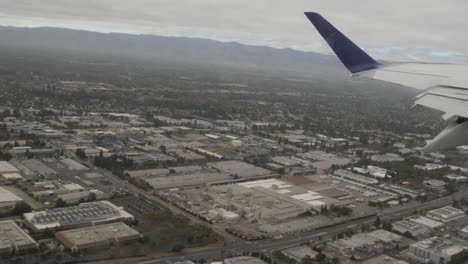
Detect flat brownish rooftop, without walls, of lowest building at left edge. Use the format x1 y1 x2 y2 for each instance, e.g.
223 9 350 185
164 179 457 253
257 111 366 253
0 220 37 249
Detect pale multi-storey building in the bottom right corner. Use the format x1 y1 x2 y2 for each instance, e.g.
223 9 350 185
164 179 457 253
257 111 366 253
406 236 465 264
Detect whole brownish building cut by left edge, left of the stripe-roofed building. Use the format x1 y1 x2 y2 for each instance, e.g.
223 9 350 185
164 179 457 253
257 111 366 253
0 220 38 254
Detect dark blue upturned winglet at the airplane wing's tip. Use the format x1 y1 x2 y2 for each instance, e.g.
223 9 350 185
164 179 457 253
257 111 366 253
305 12 380 73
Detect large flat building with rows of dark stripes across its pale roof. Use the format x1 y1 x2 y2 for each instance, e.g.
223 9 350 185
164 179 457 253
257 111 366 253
23 201 134 231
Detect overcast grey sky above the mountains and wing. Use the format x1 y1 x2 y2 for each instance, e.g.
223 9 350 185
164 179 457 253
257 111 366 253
0 0 468 63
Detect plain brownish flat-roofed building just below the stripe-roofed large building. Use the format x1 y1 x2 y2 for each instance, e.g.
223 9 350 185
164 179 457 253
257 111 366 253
55 222 143 251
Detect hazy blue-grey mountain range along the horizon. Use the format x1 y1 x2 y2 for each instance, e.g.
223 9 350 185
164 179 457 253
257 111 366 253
0 26 345 73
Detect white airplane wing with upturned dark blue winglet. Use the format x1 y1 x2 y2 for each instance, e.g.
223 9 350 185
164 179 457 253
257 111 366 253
305 12 468 152
